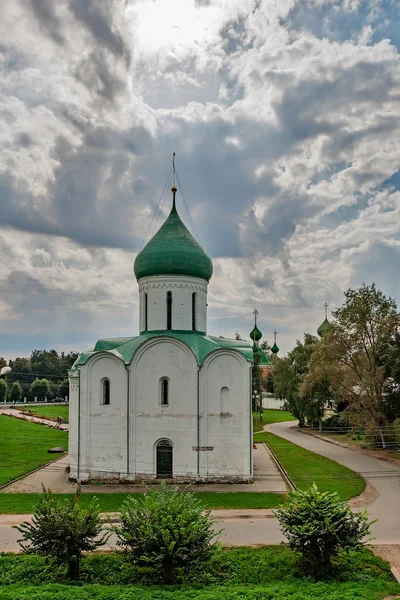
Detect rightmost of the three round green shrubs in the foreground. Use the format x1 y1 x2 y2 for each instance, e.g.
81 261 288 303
275 484 372 579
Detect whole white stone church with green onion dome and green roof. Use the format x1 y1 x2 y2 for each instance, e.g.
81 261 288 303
69 176 253 482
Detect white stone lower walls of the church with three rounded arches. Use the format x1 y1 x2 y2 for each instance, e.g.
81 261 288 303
69 336 252 481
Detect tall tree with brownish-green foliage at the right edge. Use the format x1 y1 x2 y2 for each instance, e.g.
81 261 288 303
302 284 400 448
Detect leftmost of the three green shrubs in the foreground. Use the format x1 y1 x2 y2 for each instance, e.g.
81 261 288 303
13 486 109 581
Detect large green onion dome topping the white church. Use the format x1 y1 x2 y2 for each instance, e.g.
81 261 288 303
134 202 213 281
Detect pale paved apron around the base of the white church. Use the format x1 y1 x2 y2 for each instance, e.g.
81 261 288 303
2 444 287 494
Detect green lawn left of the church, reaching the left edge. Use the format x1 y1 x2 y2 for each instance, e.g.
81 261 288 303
0 414 68 485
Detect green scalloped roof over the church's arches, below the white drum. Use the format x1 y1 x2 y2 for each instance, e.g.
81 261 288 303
73 330 253 369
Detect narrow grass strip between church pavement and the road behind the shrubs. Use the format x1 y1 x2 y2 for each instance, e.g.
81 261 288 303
0 491 287 515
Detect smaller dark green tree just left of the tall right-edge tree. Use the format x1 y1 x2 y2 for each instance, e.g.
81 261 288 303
274 333 332 427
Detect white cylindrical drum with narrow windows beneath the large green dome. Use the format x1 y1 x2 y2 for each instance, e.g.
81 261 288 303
139 275 208 332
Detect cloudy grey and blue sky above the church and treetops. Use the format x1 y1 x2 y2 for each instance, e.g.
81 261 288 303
0 0 400 358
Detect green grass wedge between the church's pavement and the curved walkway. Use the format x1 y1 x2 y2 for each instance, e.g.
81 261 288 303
254 432 365 500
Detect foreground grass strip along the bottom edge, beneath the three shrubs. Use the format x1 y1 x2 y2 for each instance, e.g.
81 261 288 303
0 546 400 600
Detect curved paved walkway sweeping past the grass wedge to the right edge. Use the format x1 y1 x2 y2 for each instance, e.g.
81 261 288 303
264 421 400 544
